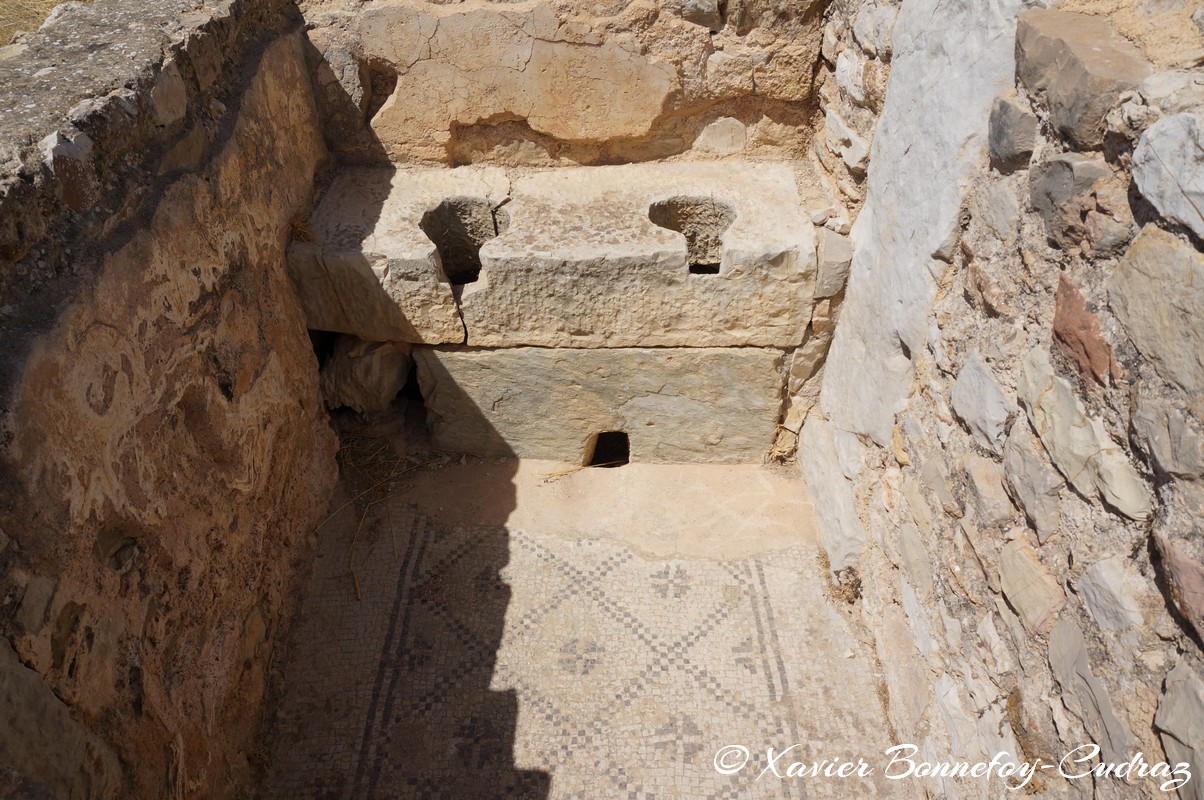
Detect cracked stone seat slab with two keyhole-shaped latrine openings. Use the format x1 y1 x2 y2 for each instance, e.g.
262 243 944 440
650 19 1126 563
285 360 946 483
289 161 815 348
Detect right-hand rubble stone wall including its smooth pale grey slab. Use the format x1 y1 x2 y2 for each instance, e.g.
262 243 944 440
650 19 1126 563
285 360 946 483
798 2 1204 798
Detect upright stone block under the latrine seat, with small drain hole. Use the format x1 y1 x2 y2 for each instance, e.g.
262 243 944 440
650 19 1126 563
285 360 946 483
414 347 783 464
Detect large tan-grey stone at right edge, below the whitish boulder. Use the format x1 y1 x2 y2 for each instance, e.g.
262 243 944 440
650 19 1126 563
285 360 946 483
1108 224 1204 395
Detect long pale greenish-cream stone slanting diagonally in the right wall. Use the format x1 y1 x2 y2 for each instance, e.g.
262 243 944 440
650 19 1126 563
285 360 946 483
1017 348 1153 520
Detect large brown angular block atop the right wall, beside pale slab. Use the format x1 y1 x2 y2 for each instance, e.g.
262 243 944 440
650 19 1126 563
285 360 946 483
1016 8 1152 148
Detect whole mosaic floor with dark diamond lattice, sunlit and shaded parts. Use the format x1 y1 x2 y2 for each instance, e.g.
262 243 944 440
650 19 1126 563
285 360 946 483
264 461 899 800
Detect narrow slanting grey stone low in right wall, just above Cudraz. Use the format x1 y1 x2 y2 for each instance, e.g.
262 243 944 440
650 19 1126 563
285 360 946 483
1050 617 1137 764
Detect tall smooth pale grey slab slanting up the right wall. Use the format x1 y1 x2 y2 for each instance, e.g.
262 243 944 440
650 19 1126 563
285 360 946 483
820 0 1022 447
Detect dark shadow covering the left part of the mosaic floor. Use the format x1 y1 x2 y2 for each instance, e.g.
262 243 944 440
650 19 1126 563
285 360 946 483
262 407 550 800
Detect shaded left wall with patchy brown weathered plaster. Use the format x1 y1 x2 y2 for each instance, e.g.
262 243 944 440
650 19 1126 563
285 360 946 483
0 4 335 798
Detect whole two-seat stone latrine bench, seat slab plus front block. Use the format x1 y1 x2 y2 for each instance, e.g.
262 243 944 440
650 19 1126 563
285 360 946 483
289 161 815 463
